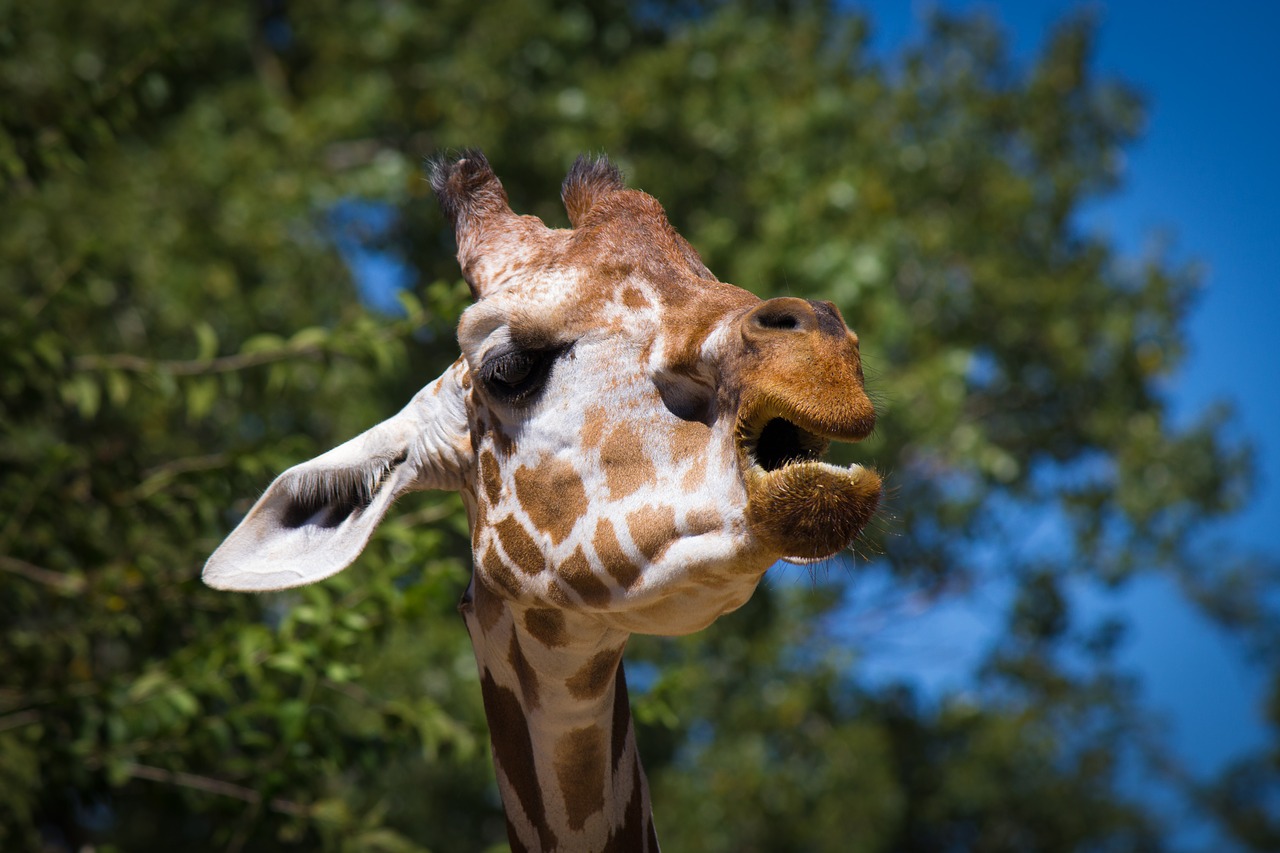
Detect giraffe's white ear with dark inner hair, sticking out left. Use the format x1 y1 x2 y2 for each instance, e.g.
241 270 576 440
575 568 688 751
204 374 466 592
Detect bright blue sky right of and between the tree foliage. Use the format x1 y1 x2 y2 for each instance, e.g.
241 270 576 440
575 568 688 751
850 0 1280 774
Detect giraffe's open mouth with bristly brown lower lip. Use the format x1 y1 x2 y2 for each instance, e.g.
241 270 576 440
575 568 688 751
737 410 881 564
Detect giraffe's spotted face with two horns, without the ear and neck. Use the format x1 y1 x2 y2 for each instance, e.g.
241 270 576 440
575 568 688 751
435 154 879 634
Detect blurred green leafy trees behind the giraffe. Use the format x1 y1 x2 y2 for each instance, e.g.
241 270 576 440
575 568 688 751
0 0 1280 850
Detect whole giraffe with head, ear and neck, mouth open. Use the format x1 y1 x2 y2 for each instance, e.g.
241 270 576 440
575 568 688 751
204 151 881 850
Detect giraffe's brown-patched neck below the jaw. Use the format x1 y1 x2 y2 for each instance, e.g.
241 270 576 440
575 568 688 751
461 580 658 853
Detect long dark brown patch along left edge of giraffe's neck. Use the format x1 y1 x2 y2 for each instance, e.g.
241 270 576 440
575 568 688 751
480 669 559 850
